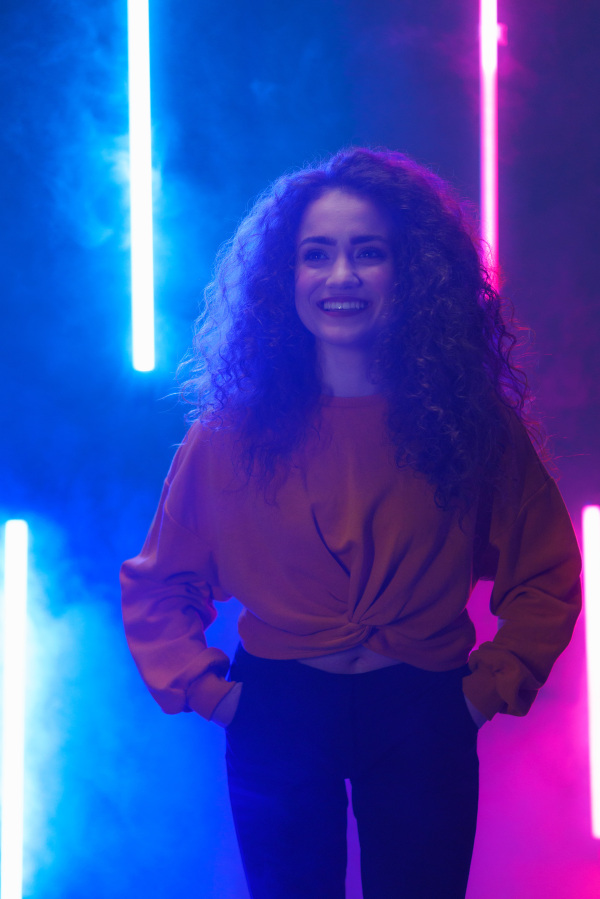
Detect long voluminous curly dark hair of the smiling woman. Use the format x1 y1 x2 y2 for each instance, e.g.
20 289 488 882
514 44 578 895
180 148 535 508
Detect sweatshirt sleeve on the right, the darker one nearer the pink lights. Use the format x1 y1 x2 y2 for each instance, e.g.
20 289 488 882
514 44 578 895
463 423 581 718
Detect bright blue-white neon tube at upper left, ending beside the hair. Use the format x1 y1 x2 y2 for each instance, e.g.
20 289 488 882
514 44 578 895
127 0 154 371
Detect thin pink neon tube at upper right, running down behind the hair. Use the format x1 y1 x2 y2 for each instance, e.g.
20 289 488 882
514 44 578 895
479 0 498 287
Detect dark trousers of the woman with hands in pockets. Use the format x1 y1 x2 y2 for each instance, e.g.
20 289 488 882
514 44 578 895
227 647 479 899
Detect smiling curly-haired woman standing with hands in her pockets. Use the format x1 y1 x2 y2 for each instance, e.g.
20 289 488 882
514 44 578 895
122 149 580 899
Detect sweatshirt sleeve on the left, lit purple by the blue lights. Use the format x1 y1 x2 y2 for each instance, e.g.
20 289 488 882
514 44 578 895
121 429 233 718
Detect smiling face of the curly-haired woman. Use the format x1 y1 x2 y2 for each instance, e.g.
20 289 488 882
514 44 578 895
295 189 395 351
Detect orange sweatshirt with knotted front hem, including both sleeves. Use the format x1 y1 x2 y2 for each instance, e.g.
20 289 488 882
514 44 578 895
121 395 581 718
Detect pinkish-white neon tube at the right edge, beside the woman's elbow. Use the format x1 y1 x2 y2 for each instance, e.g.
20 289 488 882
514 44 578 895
583 506 600 839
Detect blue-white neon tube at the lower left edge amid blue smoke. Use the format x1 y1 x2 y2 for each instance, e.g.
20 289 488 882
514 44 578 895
0 520 28 899
